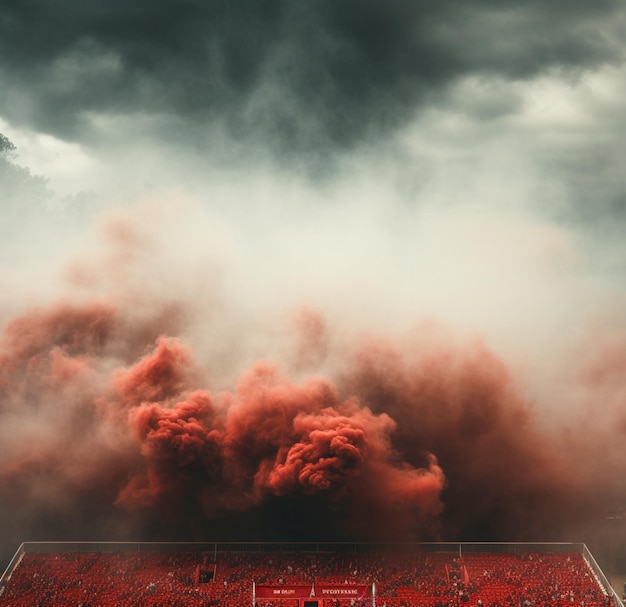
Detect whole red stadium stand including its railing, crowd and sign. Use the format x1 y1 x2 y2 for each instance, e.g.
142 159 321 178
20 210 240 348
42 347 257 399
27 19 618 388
0 543 623 607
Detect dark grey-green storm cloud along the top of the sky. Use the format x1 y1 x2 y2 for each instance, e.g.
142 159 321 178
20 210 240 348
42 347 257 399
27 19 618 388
0 0 621 159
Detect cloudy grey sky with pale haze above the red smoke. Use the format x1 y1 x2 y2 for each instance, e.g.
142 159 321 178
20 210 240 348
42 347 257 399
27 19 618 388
0 0 626 564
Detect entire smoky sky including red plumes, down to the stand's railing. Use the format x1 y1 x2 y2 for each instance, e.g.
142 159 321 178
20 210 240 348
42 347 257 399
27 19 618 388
0 0 626 576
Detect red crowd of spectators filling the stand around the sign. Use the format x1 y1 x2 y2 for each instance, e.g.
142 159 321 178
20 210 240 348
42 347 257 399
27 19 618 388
0 552 613 607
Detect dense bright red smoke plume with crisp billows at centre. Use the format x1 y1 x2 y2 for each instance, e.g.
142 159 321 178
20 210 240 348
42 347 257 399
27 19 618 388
105 339 443 536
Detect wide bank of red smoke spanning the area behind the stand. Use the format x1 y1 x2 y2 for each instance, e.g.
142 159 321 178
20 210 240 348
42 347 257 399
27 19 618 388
0 296 624 568
